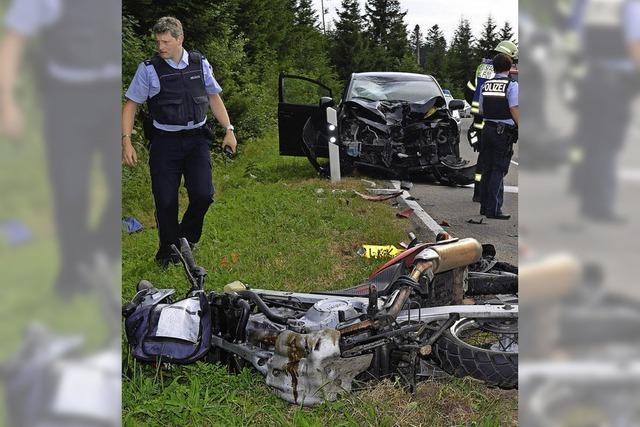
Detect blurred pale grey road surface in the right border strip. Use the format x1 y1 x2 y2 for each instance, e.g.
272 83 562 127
520 99 640 300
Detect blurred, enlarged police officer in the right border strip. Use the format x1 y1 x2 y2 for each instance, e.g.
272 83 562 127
565 0 640 223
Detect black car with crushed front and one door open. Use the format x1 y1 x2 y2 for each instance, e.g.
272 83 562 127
278 72 475 185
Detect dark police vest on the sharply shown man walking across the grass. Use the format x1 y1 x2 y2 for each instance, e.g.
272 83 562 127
145 52 209 126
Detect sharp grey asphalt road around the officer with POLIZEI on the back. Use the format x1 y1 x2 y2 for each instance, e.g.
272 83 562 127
400 119 518 264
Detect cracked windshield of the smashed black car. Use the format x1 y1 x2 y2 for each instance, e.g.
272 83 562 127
348 77 442 102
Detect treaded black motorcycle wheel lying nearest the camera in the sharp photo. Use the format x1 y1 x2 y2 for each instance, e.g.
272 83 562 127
433 318 518 389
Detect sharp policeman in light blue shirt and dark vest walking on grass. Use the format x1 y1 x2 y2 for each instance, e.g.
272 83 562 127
122 17 237 267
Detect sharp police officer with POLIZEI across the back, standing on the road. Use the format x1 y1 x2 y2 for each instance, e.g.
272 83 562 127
479 53 520 220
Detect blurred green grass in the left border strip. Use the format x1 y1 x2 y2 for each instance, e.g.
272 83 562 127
0 75 114 427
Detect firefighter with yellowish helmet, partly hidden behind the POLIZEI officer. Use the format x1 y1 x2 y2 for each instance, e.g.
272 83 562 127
464 40 518 202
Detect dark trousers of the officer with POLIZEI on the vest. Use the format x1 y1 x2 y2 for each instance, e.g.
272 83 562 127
480 123 513 216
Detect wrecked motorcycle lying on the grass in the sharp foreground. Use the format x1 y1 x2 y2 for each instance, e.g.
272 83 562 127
123 239 518 406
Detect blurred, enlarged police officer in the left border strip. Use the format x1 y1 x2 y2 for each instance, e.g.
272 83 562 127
0 0 122 297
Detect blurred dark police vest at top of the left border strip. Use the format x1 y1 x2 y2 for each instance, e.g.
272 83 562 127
40 0 122 71
